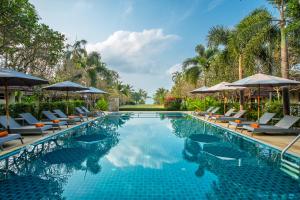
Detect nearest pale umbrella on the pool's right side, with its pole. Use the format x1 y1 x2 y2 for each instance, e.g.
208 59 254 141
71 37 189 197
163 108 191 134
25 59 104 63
227 73 300 119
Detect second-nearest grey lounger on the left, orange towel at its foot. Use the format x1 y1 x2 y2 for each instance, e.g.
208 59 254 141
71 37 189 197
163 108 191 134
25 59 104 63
0 115 52 135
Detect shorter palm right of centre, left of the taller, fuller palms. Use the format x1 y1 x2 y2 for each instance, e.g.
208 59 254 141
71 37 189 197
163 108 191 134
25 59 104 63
182 44 217 86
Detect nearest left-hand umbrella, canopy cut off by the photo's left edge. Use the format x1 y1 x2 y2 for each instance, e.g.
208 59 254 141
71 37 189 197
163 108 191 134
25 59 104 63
0 68 48 129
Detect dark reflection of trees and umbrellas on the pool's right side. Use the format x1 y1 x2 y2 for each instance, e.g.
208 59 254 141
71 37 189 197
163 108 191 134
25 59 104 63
173 117 300 199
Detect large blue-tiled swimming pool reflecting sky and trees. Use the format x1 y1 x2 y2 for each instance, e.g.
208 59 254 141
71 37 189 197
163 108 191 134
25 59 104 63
0 113 300 200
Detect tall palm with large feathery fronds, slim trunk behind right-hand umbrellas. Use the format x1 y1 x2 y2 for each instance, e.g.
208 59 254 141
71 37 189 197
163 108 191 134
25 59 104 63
208 9 273 109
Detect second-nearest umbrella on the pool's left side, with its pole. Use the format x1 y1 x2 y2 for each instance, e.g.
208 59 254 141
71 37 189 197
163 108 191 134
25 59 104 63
43 81 88 114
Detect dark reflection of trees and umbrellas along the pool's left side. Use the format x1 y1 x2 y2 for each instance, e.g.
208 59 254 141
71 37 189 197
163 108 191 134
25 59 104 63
0 116 129 200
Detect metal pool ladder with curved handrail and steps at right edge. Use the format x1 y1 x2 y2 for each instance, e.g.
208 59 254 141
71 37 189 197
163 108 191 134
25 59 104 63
280 134 300 179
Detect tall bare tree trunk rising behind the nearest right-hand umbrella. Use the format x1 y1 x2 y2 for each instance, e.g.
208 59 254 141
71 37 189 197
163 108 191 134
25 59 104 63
280 0 290 115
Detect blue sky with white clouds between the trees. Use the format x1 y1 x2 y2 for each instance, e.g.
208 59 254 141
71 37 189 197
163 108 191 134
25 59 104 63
30 0 276 95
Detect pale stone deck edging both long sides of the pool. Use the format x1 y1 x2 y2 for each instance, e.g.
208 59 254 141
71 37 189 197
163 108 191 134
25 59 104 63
0 111 300 157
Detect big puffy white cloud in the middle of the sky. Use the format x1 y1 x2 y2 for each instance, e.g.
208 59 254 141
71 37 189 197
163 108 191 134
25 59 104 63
87 29 179 74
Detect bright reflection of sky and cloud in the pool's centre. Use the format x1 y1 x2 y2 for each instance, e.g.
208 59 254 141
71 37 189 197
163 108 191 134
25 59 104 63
106 119 178 169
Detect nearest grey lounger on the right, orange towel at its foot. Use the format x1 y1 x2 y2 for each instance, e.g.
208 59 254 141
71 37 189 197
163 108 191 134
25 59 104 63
243 115 300 135
